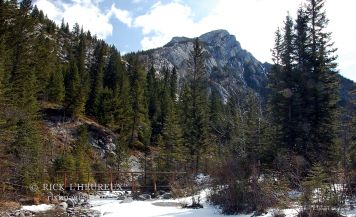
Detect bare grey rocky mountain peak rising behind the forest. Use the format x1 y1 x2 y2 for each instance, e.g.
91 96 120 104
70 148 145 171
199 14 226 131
140 30 270 97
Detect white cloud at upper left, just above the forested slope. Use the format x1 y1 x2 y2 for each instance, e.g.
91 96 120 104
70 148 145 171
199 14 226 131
35 0 132 39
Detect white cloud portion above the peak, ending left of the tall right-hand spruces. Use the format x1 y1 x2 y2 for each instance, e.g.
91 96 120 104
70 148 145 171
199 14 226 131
134 0 300 60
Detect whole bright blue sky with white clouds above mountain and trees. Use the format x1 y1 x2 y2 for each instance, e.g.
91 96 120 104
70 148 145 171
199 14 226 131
34 0 356 81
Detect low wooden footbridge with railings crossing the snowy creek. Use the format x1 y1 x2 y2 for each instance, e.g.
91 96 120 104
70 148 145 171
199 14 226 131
0 171 189 198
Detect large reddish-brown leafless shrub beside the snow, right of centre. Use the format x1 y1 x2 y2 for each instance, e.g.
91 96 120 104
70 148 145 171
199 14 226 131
209 158 288 214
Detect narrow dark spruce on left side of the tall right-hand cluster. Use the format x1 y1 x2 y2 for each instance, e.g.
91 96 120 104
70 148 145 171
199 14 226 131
270 15 299 151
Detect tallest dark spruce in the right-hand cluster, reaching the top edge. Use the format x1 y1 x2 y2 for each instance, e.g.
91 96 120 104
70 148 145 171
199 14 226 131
305 0 339 161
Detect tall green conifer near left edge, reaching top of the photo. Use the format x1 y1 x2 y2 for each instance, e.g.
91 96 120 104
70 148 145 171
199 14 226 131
3 0 43 188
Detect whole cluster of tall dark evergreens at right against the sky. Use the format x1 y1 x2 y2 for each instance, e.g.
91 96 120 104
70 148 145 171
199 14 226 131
270 0 338 166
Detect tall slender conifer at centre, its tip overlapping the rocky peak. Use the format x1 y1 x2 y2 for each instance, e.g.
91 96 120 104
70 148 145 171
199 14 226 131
182 39 208 172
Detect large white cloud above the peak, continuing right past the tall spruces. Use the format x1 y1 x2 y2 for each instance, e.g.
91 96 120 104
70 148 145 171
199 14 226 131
134 0 356 80
